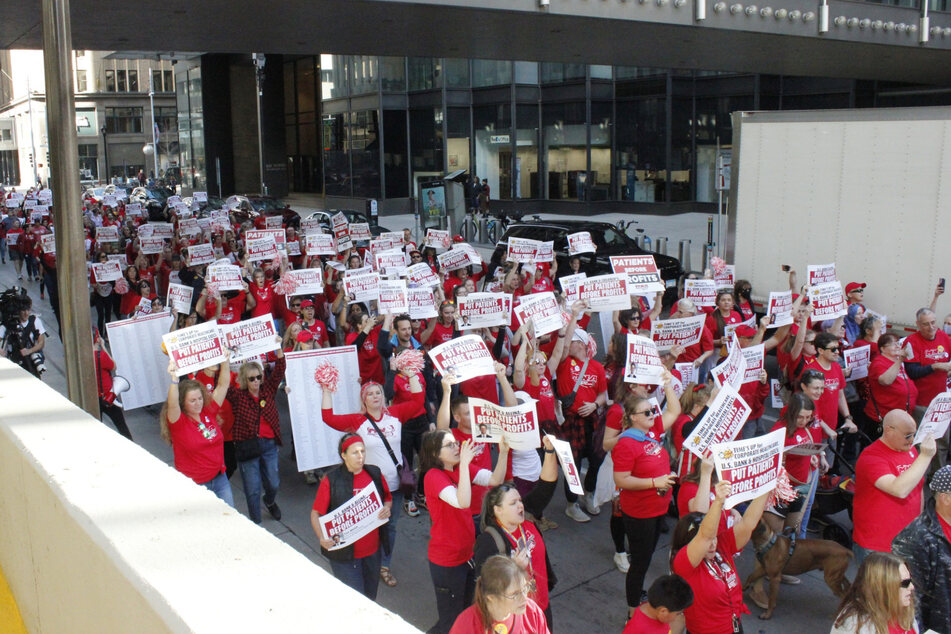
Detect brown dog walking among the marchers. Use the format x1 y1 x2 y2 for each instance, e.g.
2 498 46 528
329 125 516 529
743 520 852 619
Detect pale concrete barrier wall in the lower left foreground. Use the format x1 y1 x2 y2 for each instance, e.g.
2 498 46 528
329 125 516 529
0 359 418 634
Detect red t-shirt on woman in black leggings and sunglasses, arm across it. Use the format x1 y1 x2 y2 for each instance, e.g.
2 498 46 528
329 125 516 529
611 428 673 518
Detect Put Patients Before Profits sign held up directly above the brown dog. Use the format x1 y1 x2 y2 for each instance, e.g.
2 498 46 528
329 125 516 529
710 429 786 509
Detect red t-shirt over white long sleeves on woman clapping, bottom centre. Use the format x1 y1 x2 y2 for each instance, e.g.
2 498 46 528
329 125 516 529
423 464 480 568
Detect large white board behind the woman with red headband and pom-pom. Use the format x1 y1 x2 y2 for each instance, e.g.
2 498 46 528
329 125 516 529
285 346 360 471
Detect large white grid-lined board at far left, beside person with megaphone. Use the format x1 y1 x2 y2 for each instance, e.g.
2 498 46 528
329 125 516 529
106 312 172 410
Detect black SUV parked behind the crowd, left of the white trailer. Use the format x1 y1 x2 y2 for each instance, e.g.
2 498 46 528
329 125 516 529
489 219 683 305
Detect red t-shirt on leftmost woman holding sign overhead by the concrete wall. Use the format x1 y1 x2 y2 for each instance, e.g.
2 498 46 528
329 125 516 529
168 401 225 484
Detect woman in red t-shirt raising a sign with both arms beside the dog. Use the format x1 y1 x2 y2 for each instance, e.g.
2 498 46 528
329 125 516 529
670 480 769 634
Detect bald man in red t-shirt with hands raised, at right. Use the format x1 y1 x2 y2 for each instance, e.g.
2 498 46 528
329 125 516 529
852 410 936 564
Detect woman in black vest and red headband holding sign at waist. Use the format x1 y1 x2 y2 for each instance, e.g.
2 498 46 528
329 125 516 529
310 433 393 601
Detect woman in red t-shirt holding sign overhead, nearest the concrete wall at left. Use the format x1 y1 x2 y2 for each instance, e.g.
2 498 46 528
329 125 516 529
159 353 234 507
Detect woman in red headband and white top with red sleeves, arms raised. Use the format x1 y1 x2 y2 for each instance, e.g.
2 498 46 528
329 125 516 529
321 367 424 587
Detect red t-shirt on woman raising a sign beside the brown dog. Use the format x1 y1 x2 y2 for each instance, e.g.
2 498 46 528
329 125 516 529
671 529 749 634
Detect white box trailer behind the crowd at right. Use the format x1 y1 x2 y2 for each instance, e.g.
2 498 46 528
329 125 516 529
725 107 951 326
